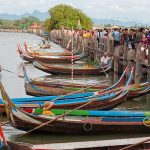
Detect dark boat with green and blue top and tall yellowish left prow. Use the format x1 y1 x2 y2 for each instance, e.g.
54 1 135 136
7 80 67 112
1 84 150 135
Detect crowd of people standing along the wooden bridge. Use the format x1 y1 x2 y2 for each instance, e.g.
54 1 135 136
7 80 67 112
51 28 150 63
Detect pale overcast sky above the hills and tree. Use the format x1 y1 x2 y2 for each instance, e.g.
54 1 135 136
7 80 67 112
0 0 150 22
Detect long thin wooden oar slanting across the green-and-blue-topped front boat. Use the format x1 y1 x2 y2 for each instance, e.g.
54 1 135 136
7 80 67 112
20 96 105 136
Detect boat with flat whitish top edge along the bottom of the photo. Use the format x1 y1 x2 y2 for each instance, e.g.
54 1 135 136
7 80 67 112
8 137 150 150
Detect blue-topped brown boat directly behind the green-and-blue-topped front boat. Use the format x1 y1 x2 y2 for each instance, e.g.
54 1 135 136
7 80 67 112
1 91 127 111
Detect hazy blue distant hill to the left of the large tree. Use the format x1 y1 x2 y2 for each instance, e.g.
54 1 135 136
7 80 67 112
0 10 49 21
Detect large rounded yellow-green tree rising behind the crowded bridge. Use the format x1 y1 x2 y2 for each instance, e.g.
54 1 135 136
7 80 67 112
45 4 93 30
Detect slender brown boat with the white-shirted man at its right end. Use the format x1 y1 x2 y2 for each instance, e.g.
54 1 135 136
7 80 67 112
33 61 112 75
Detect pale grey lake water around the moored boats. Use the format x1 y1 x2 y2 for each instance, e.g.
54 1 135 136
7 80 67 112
0 33 150 144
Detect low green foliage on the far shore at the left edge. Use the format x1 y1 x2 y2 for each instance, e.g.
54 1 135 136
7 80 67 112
0 16 40 29
